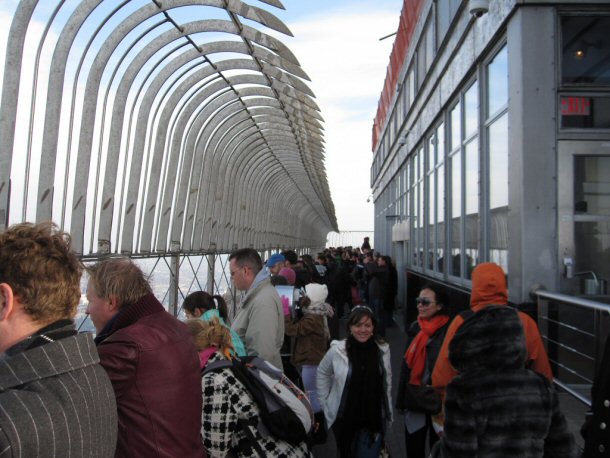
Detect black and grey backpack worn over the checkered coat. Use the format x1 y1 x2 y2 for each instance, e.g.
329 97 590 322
203 356 314 445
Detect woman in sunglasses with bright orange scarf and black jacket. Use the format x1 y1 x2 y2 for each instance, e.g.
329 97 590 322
396 285 450 458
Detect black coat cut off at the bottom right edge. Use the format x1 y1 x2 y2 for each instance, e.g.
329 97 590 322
582 335 610 458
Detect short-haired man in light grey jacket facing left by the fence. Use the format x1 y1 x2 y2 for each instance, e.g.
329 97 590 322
229 248 284 369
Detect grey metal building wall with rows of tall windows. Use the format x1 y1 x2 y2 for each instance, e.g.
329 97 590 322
371 0 610 310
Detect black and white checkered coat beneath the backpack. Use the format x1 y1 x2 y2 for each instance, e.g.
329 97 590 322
201 353 310 458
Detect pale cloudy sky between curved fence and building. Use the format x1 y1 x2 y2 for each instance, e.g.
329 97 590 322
268 0 403 231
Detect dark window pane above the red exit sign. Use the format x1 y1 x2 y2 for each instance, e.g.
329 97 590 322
561 16 610 84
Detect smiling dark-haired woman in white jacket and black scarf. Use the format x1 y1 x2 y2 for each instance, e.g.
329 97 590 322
317 305 392 458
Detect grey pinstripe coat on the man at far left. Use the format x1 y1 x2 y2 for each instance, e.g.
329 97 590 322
0 328 117 458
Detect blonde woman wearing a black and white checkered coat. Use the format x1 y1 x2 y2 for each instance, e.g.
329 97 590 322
186 318 309 458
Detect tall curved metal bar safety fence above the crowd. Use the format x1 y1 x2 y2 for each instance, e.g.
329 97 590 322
0 0 337 256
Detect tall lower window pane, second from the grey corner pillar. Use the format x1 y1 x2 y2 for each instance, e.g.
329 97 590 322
465 139 479 278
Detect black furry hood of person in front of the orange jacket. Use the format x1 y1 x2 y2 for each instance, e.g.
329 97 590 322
449 306 526 374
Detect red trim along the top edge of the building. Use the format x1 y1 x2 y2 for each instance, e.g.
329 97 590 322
373 0 423 152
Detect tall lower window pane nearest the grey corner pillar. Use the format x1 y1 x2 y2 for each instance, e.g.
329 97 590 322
489 114 508 274
